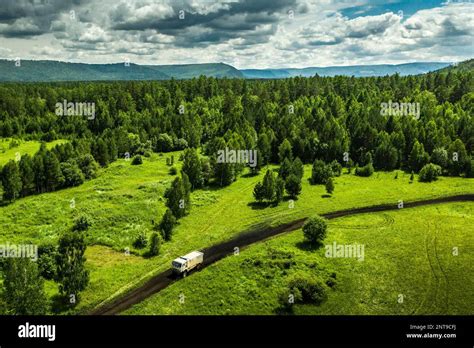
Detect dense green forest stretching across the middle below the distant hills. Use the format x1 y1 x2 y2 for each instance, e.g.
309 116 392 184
0 66 474 201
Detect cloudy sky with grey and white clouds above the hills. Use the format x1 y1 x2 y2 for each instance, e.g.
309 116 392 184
0 0 474 68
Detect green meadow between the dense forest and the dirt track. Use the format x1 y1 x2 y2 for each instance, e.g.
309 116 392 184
0 148 474 311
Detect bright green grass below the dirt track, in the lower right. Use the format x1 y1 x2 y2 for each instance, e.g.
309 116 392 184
125 202 474 315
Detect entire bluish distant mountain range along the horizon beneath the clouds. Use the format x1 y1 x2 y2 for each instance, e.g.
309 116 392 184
0 59 460 82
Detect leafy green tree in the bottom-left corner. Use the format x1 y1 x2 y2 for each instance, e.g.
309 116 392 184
2 257 48 315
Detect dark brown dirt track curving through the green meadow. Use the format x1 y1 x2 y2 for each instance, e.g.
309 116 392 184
89 194 474 315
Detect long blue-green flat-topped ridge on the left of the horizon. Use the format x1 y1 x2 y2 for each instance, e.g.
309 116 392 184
0 60 243 82
